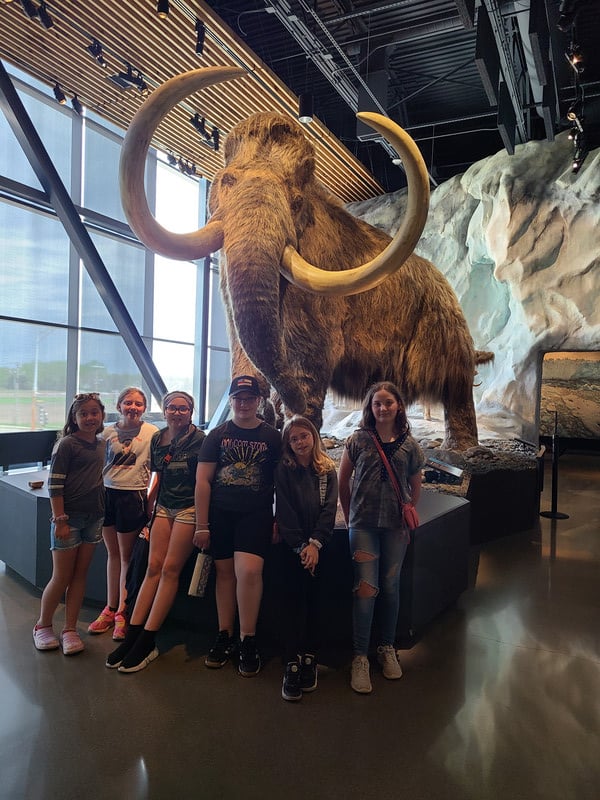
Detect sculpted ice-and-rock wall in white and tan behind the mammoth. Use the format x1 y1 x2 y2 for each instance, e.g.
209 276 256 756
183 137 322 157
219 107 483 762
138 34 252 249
349 133 600 441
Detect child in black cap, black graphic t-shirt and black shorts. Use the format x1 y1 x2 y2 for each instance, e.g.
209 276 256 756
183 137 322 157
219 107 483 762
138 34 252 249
194 375 281 677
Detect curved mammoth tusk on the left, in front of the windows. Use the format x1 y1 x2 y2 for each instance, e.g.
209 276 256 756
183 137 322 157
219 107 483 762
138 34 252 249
119 67 246 261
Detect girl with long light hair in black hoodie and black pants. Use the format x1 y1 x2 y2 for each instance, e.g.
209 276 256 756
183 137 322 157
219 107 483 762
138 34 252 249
275 416 338 701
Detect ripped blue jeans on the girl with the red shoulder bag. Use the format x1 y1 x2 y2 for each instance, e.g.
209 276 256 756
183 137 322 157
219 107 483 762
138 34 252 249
349 528 408 656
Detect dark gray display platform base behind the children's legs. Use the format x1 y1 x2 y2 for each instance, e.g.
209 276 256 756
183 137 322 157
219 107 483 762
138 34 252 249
0 469 470 647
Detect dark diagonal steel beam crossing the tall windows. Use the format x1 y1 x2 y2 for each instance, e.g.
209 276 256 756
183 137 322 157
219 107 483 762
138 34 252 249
0 60 167 402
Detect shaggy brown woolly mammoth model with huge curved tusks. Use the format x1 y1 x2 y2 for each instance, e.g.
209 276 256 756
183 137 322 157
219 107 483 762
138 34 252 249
121 67 490 449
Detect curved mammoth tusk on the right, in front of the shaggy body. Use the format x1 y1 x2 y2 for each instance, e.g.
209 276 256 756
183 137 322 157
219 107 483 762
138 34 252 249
280 112 429 295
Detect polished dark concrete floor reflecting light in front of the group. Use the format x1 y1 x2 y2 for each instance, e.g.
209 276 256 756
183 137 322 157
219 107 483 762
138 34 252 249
0 453 600 800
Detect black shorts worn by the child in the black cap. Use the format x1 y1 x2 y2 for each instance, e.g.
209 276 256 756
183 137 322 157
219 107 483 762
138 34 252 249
209 508 273 561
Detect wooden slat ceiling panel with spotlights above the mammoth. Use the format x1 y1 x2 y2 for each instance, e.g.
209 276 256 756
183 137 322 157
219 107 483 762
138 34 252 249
0 0 383 202
